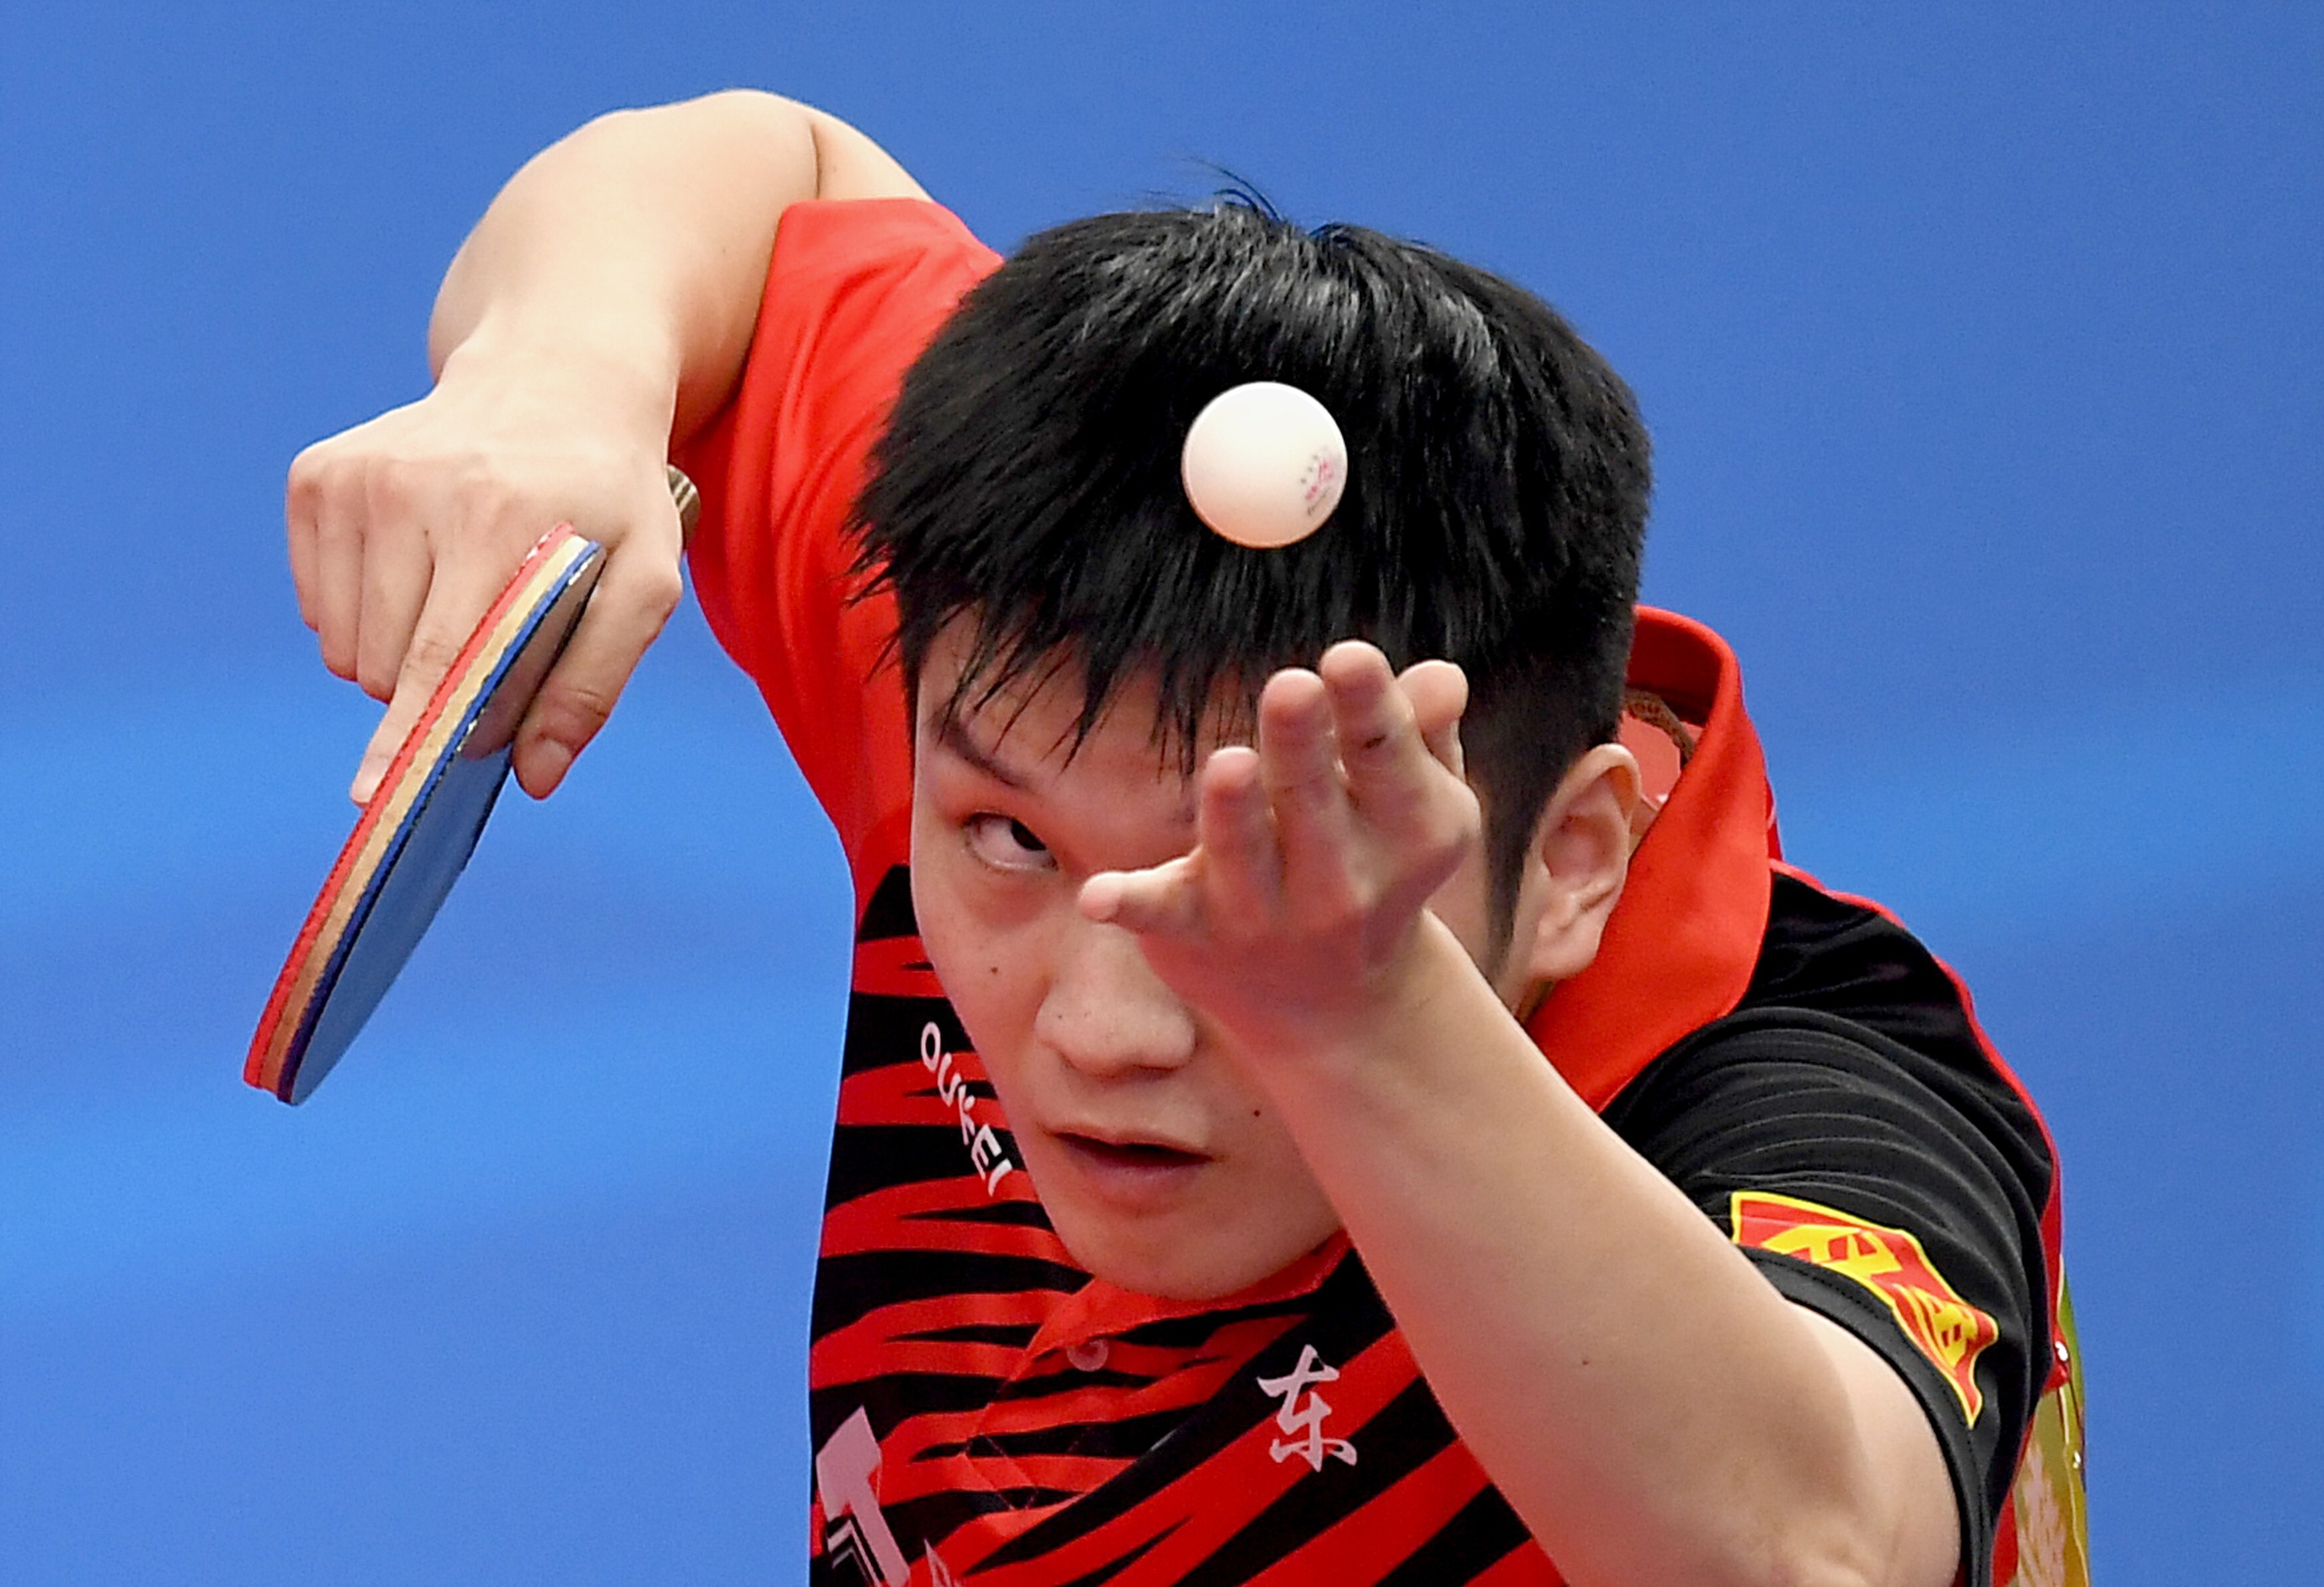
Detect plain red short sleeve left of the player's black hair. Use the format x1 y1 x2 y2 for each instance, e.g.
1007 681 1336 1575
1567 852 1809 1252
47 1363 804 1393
677 200 999 857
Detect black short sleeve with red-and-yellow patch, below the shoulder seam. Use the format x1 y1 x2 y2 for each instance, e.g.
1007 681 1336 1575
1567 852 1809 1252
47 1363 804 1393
1606 1009 2050 1587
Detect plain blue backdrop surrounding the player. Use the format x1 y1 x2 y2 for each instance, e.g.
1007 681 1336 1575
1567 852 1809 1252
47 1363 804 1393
0 0 2324 1587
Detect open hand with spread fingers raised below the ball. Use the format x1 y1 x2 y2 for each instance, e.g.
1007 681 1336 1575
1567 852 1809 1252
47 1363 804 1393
1081 641 1481 1068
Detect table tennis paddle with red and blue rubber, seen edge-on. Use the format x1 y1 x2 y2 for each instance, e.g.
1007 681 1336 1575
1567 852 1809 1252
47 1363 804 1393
242 467 700 1102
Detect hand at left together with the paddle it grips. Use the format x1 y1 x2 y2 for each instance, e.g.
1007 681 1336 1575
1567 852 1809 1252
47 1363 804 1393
261 353 695 1102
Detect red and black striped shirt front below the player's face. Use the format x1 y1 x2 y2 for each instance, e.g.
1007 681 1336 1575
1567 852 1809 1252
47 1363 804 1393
809 867 1557 1587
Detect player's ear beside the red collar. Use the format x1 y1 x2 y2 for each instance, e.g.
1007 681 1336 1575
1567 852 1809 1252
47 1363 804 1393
1511 744 1639 1004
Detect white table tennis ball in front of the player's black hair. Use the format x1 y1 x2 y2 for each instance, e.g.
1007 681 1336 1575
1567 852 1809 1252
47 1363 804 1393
1179 381 1348 546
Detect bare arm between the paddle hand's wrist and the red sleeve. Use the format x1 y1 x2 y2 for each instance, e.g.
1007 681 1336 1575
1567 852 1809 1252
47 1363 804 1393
428 93 918 437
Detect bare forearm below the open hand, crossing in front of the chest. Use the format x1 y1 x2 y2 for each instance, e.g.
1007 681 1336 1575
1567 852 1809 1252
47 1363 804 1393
1269 920 1934 1585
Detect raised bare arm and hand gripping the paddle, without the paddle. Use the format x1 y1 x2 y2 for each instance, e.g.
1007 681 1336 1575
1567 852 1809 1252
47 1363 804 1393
286 93 923 799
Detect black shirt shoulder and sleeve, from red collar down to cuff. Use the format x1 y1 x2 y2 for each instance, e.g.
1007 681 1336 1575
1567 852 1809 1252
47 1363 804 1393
1606 869 2057 1580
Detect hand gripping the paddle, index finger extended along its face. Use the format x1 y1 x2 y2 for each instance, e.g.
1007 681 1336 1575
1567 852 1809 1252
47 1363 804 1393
286 346 681 804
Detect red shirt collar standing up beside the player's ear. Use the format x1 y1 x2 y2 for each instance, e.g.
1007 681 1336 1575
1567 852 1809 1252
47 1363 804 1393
1525 606 1778 1108
